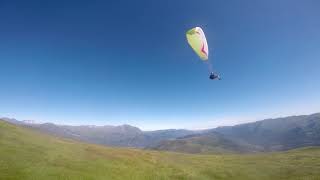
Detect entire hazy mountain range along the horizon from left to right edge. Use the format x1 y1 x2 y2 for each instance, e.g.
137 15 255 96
2 113 320 154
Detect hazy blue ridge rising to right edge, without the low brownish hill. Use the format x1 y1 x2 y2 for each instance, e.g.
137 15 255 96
211 113 320 151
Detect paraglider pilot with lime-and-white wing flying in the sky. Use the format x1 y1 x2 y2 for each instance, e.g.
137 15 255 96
186 27 221 80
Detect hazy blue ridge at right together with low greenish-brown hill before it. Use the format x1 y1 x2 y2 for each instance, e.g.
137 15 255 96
149 113 320 153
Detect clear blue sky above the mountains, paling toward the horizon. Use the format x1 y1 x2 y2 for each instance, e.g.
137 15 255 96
0 0 320 130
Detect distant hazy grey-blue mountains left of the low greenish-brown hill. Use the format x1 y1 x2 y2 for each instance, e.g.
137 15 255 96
3 118 194 148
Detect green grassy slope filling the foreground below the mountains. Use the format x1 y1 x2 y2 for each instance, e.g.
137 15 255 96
0 121 320 180
